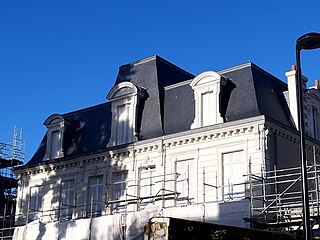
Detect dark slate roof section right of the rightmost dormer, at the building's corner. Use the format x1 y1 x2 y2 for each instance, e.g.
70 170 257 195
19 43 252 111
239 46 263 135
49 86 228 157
221 62 293 126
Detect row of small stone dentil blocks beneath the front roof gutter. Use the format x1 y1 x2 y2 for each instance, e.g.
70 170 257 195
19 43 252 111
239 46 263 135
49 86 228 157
21 118 264 175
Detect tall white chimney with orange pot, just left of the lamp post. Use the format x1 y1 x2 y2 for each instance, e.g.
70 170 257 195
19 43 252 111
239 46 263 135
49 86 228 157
286 65 308 130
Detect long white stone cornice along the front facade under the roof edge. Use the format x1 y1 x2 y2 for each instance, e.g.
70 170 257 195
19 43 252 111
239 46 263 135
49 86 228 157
16 116 265 175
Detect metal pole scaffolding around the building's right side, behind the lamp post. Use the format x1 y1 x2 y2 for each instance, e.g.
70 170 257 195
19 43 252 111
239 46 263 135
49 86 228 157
248 163 320 231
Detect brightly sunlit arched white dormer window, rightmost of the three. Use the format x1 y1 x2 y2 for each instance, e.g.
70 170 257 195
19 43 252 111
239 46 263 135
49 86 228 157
190 71 235 128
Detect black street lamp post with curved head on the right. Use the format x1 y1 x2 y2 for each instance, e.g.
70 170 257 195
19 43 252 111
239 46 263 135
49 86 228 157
296 33 320 240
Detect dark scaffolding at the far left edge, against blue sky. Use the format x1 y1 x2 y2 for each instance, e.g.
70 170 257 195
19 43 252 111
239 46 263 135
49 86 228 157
0 127 26 239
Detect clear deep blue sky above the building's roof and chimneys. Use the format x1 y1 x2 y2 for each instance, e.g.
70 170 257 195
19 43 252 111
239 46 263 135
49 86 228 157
0 0 320 160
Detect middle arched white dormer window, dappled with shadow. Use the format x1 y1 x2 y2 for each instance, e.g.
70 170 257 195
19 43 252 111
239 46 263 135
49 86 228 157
107 82 145 147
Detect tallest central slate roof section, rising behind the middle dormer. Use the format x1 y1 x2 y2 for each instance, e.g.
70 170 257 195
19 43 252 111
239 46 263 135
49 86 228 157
115 56 194 139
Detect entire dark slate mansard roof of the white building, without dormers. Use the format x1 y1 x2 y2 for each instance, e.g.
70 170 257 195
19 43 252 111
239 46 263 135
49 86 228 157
22 56 292 168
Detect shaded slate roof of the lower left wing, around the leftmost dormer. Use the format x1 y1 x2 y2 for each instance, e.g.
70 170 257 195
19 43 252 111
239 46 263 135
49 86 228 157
26 102 111 165
